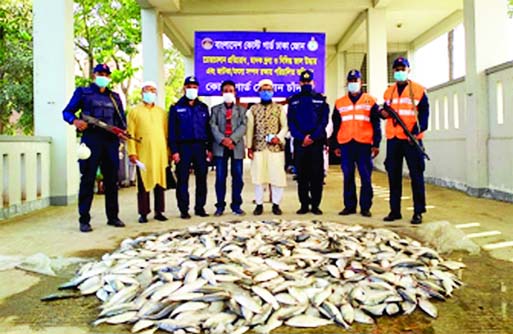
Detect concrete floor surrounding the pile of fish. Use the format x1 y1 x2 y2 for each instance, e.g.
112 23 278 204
0 166 513 333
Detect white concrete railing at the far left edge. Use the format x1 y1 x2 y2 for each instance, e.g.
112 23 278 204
0 136 51 220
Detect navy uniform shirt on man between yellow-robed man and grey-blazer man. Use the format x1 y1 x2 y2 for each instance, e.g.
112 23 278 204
168 96 212 152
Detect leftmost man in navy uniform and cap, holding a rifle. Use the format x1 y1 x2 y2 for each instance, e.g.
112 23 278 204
62 64 126 232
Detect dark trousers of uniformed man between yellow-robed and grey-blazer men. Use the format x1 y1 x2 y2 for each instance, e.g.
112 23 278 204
176 143 207 212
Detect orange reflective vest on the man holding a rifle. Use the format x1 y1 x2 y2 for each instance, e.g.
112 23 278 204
384 80 425 139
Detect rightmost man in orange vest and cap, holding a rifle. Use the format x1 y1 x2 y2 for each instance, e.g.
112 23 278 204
381 57 429 224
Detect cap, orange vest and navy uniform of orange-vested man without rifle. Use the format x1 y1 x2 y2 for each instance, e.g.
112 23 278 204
332 70 381 217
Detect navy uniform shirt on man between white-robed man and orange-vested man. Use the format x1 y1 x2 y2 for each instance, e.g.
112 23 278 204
287 91 330 142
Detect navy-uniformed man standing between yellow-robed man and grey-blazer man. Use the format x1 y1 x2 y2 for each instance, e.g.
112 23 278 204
168 76 212 219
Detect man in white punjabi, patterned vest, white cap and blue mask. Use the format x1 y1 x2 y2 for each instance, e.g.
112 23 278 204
246 79 288 216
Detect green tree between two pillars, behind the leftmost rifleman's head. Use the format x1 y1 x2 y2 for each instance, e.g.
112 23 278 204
74 0 141 96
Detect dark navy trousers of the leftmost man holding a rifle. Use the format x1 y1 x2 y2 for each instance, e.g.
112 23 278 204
78 133 119 223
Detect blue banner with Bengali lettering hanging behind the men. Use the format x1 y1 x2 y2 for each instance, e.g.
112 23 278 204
194 31 326 97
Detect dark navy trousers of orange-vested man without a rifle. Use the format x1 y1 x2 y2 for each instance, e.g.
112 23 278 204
340 140 373 211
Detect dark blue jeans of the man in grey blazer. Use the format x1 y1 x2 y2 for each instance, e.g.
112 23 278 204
214 149 244 210
